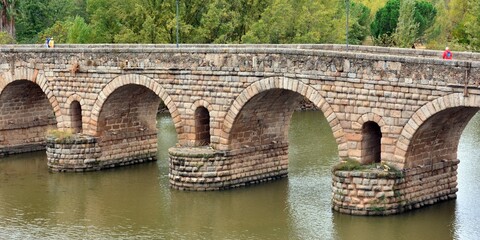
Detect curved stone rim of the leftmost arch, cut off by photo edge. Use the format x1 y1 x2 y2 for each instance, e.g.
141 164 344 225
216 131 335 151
0 67 62 125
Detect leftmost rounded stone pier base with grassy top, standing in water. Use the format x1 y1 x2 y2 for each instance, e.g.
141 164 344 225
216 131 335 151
47 133 157 172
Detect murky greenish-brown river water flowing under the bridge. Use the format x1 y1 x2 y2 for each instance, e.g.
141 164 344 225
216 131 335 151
0 112 480 240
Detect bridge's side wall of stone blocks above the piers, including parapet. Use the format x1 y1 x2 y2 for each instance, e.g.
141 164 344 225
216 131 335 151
0 45 480 167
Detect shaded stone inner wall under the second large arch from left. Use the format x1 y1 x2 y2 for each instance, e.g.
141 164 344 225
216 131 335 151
96 84 161 165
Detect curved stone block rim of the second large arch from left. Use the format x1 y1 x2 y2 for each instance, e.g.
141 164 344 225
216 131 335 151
88 74 183 137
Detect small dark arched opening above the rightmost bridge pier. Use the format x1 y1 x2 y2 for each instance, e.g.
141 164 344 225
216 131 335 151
361 121 382 164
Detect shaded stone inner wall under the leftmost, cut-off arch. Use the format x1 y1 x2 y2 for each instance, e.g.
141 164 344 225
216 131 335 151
0 80 57 153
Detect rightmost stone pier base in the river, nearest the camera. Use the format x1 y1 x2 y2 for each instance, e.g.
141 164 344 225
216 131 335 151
332 160 459 215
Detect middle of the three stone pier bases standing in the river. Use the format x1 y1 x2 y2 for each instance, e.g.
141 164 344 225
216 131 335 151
168 143 288 191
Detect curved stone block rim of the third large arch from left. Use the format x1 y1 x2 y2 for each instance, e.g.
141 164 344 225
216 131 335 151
221 77 347 157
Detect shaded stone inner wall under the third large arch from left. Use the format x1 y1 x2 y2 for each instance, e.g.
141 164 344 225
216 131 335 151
229 88 338 181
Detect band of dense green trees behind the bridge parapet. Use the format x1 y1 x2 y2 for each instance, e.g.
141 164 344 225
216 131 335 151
0 0 480 51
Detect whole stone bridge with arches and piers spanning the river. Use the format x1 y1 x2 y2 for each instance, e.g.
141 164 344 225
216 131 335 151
0 45 480 214
